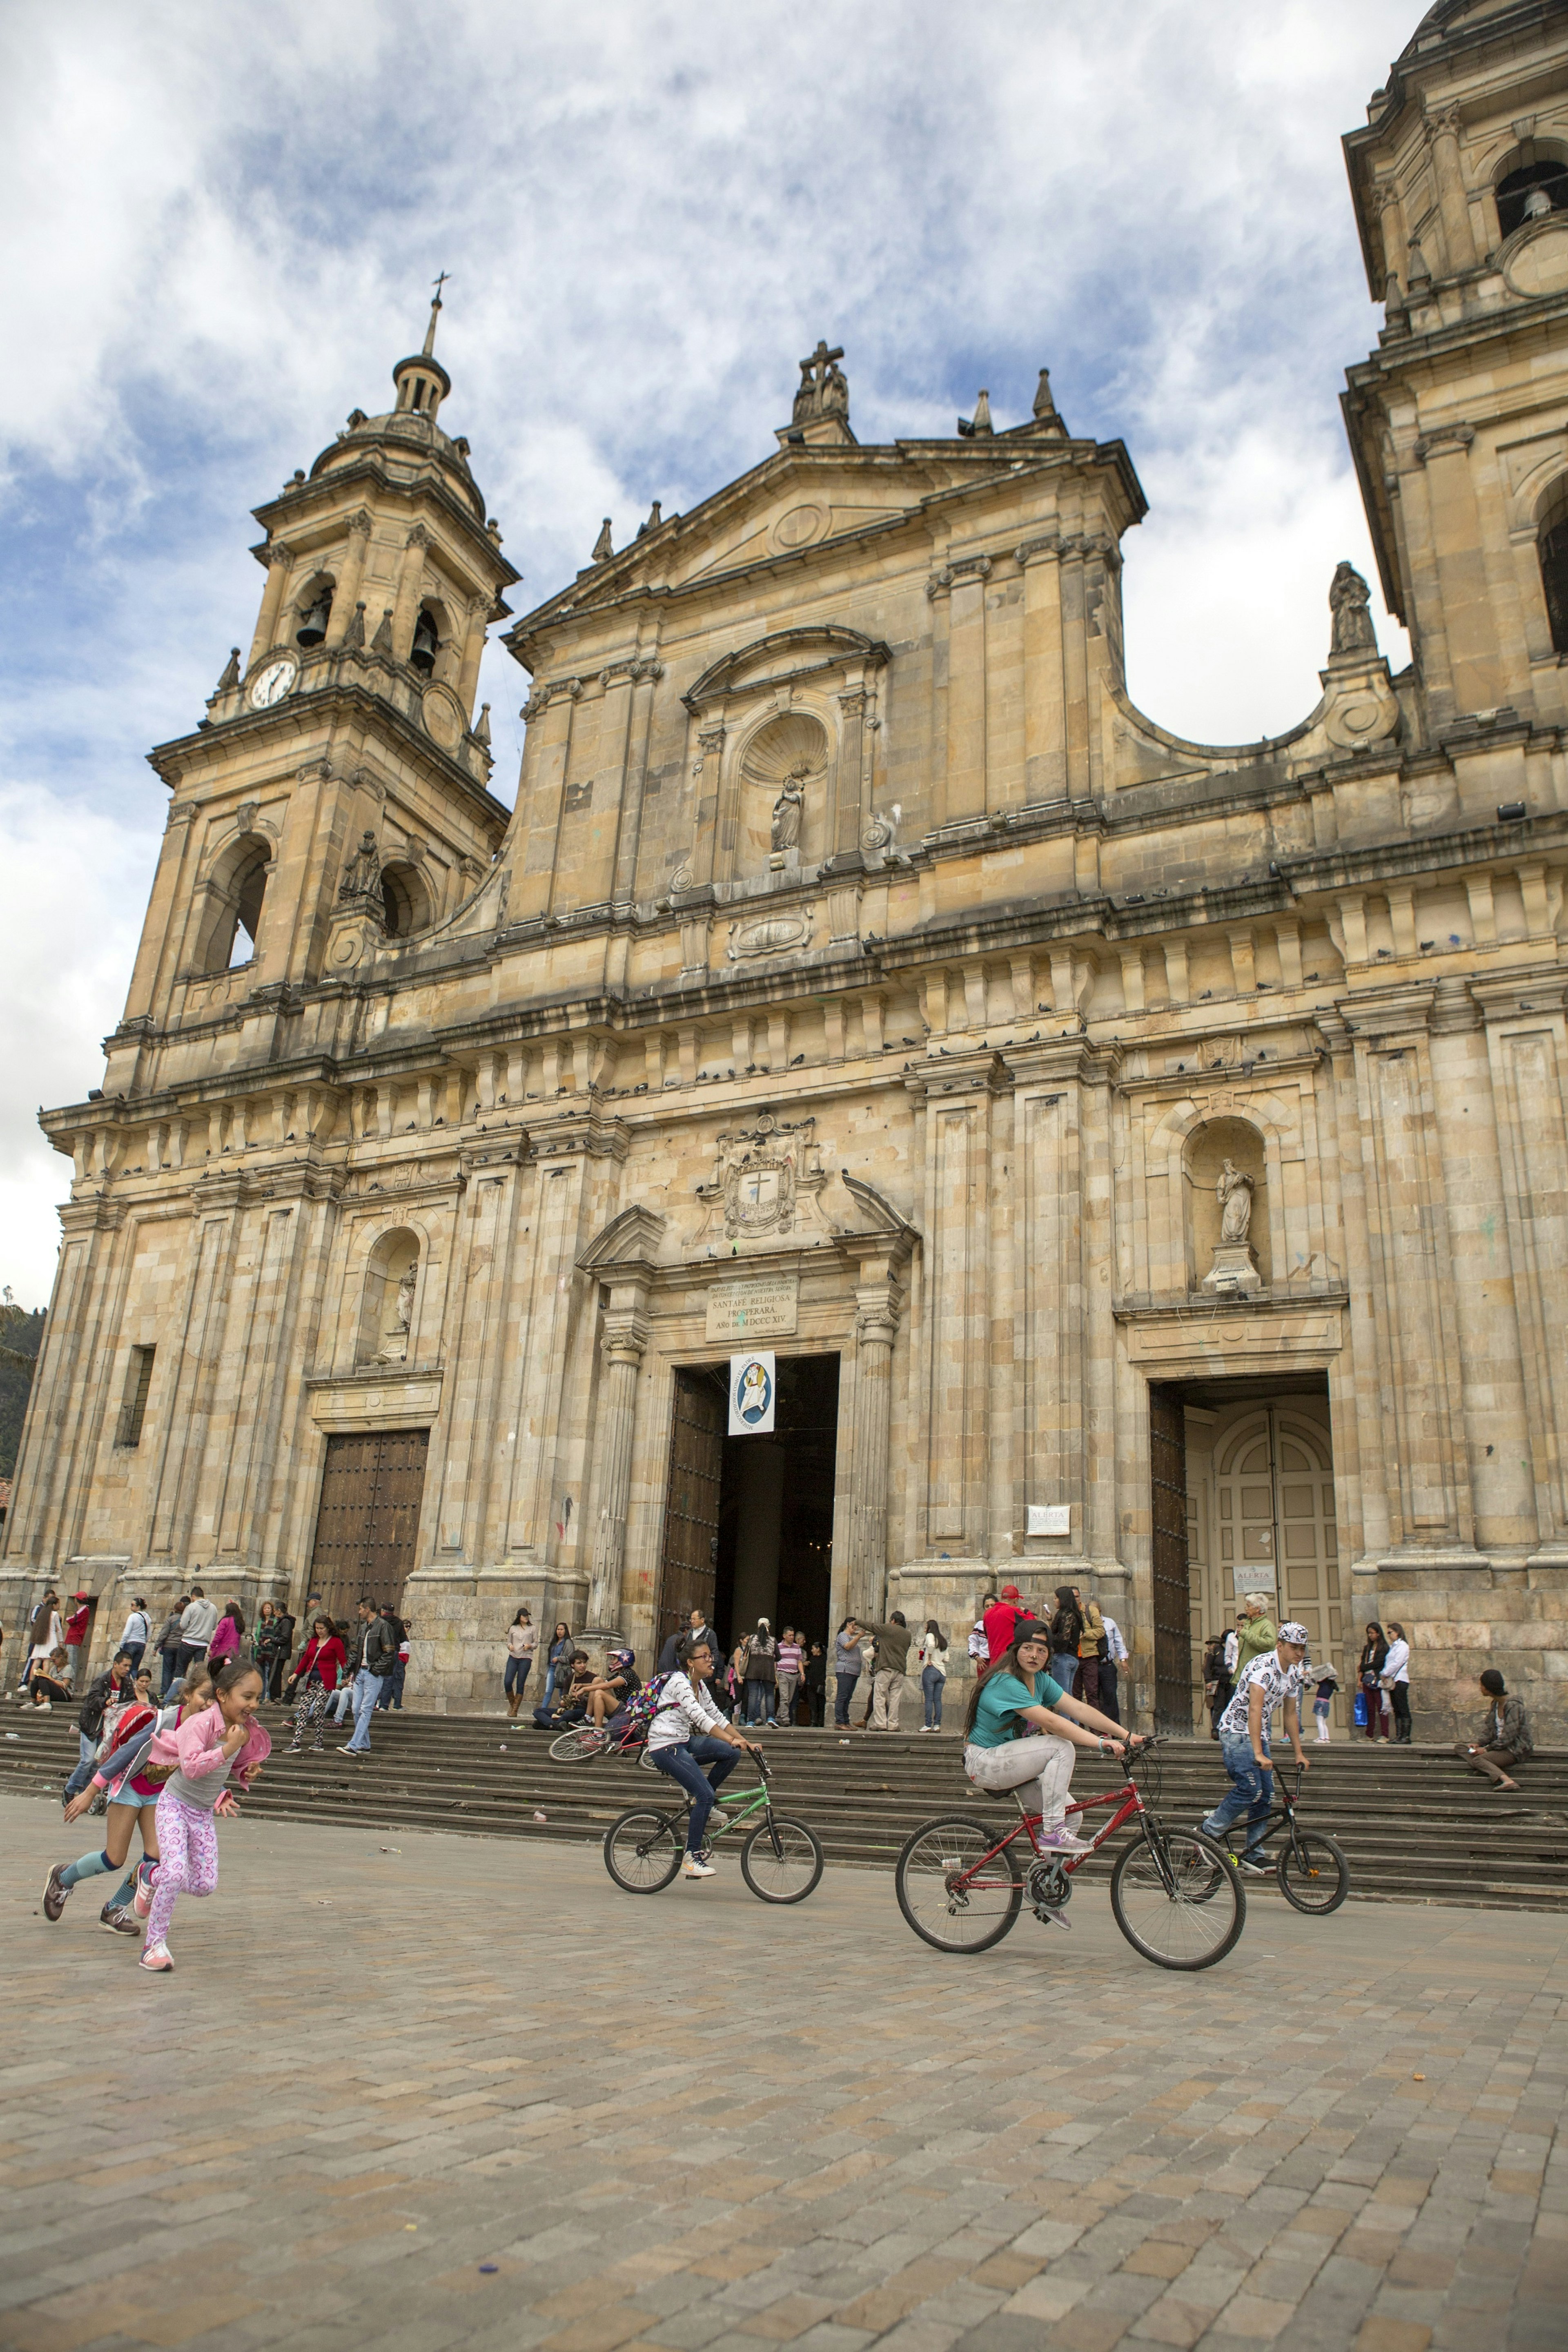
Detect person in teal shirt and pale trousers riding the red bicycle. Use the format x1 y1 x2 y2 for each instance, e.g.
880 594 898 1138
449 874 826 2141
964 1618 1143 1853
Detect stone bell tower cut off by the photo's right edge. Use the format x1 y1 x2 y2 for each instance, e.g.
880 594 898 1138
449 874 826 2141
1345 0 1568 748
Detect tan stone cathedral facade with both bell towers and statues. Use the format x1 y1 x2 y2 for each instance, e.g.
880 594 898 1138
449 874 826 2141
0 0 1568 1736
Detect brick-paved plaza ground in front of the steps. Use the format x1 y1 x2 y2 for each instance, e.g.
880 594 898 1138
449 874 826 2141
0 1799 1568 2352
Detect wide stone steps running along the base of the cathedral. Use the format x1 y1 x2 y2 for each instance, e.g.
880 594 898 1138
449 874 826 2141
0 1705 1568 1910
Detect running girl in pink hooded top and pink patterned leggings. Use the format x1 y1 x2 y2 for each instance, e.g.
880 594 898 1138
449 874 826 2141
131 1658 273 1976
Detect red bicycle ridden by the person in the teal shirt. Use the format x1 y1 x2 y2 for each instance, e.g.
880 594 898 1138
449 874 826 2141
893 1740 1246 1969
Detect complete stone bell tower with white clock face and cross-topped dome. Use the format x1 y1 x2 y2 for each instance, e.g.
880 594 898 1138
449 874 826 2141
103 292 517 1096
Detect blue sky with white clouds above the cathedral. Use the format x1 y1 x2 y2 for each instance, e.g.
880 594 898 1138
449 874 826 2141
0 0 1420 1305
